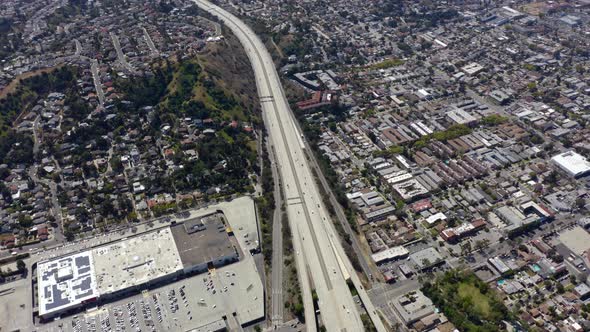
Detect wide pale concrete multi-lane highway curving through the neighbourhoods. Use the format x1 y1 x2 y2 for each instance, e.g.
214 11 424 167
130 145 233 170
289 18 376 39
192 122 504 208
193 0 385 331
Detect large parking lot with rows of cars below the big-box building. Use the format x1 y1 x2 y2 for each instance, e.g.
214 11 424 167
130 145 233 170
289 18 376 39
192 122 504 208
39 256 264 332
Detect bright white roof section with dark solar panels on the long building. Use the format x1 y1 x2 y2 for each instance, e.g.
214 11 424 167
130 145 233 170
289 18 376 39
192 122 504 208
37 251 98 316
